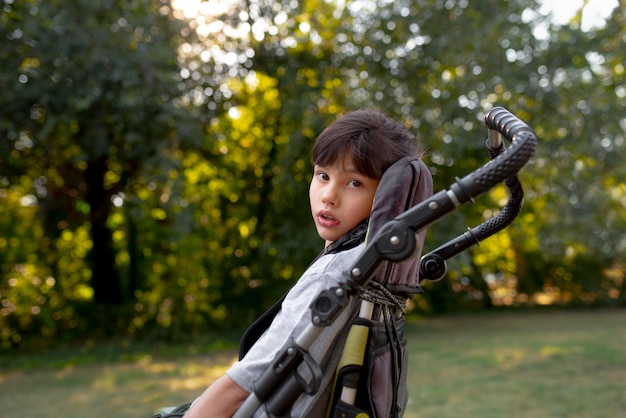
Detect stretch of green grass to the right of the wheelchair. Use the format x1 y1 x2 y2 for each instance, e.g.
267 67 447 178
405 310 626 418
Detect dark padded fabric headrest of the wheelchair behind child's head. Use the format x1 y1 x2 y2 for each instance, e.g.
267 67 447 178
368 157 433 296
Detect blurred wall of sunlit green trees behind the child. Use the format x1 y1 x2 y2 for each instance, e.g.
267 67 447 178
0 0 626 349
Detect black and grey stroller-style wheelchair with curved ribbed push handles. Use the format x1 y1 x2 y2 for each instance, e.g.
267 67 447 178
152 107 537 418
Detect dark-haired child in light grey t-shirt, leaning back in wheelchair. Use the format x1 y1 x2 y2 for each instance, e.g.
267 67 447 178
185 110 422 418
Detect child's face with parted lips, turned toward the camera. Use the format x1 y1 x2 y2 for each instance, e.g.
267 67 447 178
309 155 379 245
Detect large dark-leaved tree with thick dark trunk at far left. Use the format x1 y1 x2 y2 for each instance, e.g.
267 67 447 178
0 0 196 305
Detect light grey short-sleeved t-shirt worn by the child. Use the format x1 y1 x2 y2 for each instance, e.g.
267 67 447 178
226 244 364 418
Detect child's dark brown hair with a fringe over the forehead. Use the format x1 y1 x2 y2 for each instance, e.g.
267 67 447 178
311 110 423 179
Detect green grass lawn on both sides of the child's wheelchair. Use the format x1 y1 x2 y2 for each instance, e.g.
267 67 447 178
0 309 626 418
